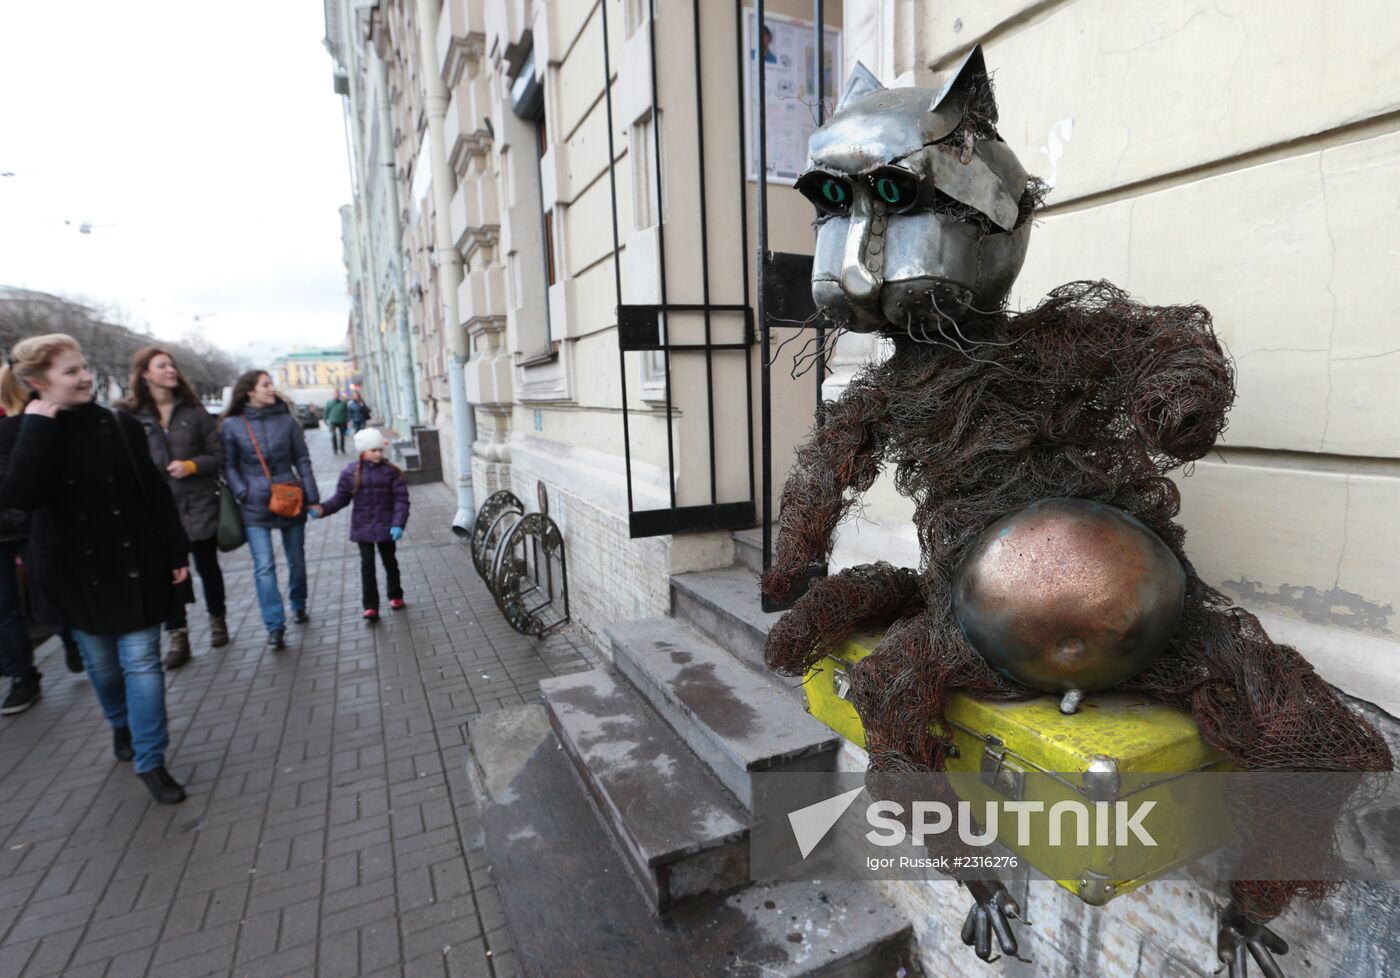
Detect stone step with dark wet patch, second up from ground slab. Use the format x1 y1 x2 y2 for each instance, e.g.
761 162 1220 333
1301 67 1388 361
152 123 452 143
608 618 840 812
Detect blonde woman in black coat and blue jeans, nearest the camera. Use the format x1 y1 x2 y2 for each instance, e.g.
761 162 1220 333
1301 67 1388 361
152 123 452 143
0 333 189 805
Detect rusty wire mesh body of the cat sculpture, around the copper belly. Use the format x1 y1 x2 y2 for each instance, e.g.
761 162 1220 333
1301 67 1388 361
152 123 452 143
763 281 1392 921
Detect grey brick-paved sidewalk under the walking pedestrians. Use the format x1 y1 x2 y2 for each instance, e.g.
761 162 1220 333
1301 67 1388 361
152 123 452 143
0 432 596 978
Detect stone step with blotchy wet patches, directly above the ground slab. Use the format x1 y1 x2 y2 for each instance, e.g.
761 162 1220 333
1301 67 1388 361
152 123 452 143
540 669 749 912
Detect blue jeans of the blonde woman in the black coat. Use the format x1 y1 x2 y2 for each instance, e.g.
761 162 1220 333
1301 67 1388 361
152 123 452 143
71 625 169 774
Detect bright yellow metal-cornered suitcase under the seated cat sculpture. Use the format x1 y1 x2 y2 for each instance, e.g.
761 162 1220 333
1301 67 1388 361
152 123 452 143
804 632 1233 905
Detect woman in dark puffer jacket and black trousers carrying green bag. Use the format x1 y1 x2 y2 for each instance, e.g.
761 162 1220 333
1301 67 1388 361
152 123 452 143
122 347 228 669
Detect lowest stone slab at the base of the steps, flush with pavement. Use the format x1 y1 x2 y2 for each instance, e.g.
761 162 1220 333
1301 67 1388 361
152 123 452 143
468 705 920 978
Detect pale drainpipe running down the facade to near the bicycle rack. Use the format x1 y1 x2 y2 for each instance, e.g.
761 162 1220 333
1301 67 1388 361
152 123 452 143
417 0 476 536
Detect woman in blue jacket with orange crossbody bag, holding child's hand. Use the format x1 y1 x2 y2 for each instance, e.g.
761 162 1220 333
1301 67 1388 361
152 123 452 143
220 371 321 649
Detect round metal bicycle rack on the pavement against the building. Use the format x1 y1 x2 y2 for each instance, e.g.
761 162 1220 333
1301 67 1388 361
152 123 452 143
472 486 568 635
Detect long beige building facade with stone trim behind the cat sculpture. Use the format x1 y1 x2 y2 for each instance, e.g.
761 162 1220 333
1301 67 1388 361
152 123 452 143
328 0 1400 975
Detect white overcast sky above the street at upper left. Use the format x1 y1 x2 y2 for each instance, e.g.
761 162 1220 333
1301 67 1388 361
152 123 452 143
0 0 350 358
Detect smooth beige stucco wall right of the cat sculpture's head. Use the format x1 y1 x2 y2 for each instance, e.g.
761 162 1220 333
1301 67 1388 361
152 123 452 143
836 0 1400 712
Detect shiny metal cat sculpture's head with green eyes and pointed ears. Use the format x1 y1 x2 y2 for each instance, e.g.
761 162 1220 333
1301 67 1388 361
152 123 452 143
797 48 1044 332
